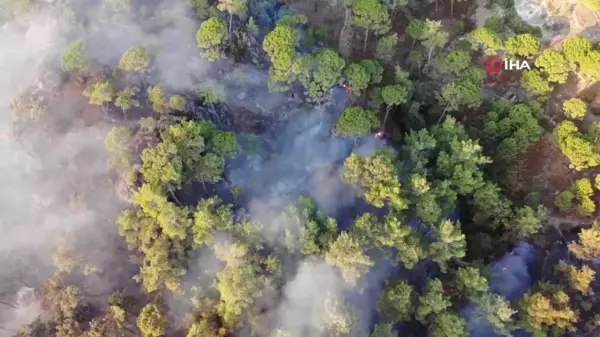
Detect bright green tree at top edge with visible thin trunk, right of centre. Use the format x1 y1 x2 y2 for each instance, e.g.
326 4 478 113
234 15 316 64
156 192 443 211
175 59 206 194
352 0 391 51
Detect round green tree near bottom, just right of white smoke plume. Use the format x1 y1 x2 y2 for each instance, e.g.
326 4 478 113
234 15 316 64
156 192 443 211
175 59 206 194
379 280 416 324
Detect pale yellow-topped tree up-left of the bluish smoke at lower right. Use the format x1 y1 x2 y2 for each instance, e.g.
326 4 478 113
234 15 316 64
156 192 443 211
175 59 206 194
430 220 467 271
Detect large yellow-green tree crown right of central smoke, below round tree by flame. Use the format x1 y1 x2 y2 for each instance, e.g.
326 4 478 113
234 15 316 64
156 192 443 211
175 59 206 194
342 153 408 209
